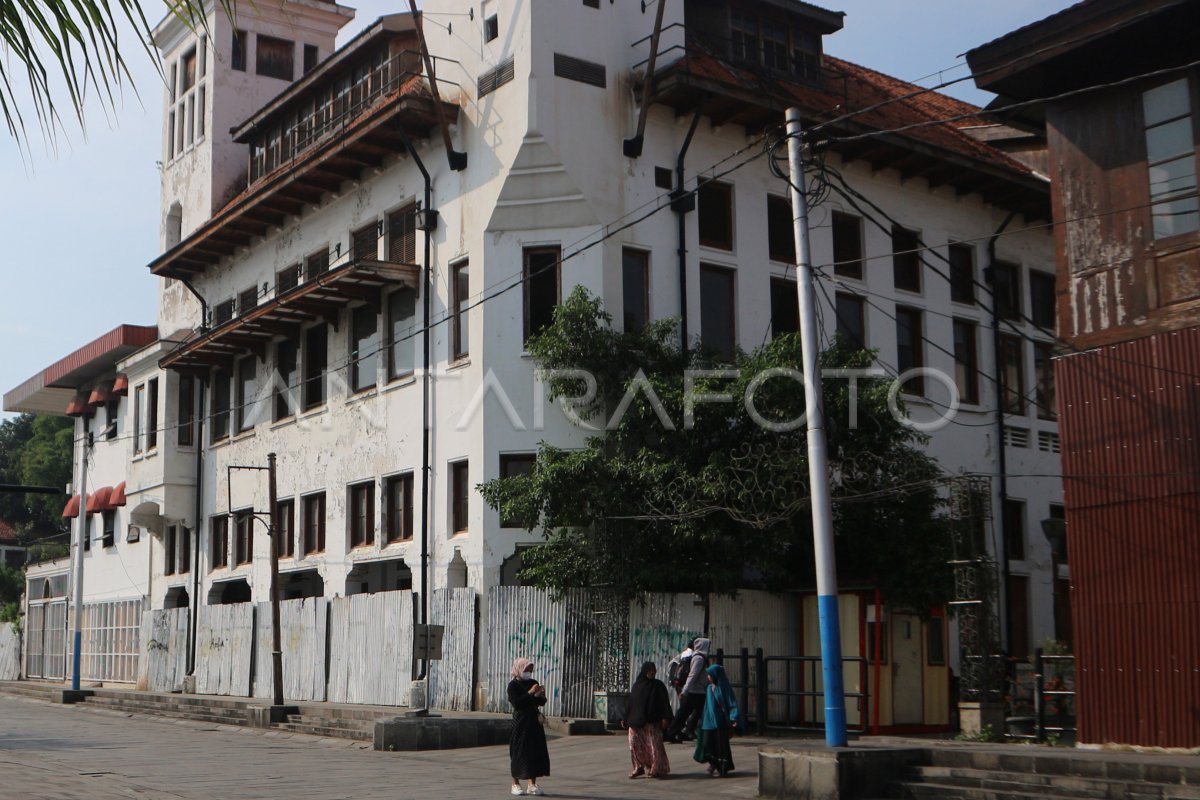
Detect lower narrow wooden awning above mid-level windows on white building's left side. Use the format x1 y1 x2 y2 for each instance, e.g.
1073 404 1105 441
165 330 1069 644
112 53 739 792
160 259 421 372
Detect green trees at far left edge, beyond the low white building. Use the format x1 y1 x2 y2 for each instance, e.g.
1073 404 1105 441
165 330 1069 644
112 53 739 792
0 414 74 541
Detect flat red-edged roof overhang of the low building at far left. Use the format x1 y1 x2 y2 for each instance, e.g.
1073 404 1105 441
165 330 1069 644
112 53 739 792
4 325 158 416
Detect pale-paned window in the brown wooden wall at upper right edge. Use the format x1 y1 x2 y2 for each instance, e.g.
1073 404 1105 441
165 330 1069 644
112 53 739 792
1141 77 1200 239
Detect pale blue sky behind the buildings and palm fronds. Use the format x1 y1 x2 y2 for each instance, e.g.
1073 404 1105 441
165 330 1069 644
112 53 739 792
0 0 1074 419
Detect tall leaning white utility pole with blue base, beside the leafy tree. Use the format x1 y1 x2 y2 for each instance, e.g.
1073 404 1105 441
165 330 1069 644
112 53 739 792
787 108 846 747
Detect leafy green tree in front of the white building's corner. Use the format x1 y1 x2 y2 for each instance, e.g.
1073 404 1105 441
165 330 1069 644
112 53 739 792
480 288 952 612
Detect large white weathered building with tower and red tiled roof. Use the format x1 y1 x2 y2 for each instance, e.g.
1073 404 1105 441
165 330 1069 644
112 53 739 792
7 0 1061 724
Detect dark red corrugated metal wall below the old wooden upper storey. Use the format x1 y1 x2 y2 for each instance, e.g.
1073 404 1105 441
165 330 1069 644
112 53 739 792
1056 329 1200 747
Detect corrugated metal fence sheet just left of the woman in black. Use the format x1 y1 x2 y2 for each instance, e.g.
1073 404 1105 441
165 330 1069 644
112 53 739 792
430 589 476 711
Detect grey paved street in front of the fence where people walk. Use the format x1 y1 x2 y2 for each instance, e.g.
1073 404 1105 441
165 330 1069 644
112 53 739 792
0 696 766 800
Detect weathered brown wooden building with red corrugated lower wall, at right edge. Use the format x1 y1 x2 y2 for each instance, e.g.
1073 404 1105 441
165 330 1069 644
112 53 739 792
968 0 1200 747
